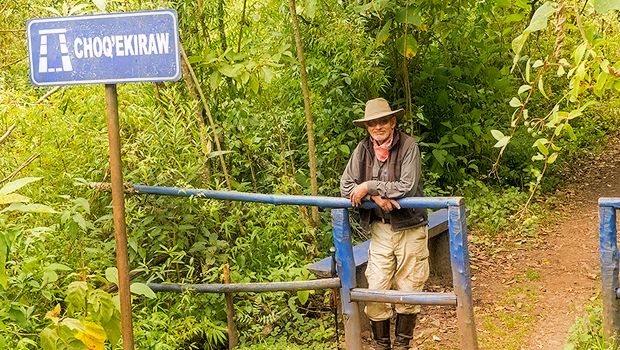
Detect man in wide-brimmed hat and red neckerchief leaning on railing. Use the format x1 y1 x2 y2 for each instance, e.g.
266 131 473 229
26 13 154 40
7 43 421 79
340 98 429 350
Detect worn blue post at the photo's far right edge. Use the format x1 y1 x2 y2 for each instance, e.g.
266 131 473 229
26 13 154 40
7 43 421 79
599 202 620 337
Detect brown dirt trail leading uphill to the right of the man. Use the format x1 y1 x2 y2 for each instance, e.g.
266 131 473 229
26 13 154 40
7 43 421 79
416 137 620 350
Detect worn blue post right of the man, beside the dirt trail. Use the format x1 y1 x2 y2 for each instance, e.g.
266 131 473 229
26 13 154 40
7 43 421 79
448 198 478 350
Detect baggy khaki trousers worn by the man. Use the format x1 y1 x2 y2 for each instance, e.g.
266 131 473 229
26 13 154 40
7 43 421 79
365 221 429 321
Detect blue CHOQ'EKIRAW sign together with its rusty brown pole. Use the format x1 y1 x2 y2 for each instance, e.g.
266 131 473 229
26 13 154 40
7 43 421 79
26 10 181 350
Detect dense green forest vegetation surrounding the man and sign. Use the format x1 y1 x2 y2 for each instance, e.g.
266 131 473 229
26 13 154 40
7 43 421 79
0 0 620 349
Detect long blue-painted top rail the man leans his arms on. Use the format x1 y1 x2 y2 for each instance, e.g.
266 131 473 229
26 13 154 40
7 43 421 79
128 185 464 209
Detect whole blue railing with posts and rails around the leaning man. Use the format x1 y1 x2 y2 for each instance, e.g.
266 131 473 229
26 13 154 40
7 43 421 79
112 184 478 350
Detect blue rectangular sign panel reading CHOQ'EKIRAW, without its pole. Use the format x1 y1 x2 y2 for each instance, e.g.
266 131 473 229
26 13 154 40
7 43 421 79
26 10 181 86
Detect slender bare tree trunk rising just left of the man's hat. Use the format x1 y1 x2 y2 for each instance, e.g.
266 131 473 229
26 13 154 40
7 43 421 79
288 0 319 227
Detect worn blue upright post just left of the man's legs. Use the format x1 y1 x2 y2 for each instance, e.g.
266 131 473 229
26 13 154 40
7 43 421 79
332 209 362 350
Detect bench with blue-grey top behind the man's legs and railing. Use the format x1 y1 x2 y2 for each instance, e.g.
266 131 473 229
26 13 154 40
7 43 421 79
308 209 452 331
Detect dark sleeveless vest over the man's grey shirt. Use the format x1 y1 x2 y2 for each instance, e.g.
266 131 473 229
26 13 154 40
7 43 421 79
360 131 428 231
